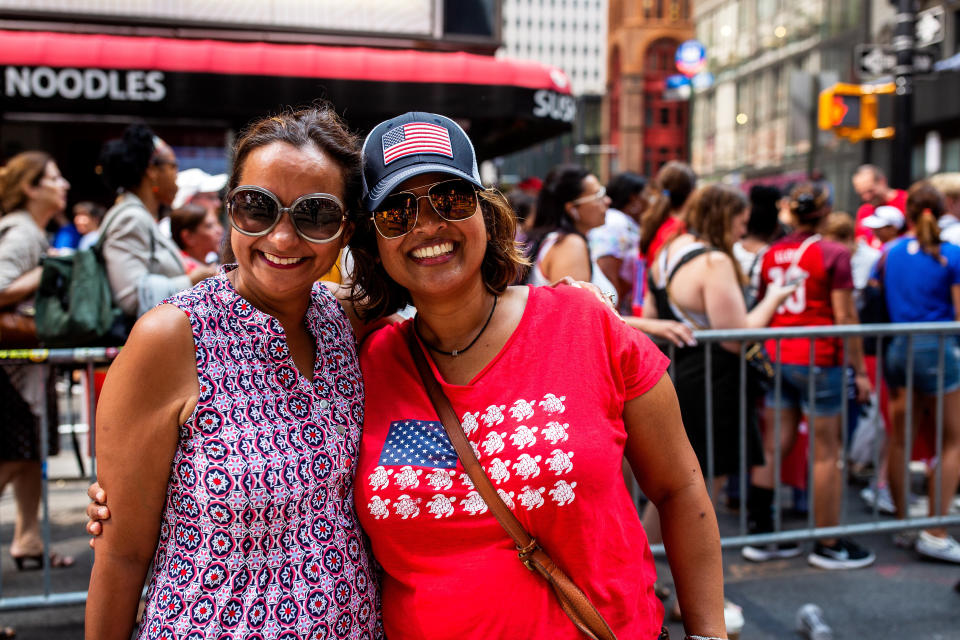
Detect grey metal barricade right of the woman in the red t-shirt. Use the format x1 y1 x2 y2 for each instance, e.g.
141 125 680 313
652 322 960 555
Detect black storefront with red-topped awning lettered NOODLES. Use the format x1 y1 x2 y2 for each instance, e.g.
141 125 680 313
0 31 576 200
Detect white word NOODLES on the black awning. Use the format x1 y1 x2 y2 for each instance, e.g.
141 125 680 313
4 67 167 102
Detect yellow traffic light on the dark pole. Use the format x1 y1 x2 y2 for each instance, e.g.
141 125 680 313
817 83 894 142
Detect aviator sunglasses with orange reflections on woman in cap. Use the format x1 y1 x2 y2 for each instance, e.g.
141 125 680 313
372 178 479 238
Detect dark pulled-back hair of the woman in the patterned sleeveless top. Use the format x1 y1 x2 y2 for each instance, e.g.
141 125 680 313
221 101 362 263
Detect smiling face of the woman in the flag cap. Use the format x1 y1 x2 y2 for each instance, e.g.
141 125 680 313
377 173 487 302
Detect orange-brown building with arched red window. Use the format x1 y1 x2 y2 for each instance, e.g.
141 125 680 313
604 0 695 176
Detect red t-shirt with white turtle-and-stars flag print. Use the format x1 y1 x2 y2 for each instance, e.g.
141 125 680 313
354 287 667 640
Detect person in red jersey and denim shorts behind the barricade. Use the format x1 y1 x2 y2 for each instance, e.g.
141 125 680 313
743 184 875 569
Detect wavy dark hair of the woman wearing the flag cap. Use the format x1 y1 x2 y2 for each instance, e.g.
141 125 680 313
348 189 527 321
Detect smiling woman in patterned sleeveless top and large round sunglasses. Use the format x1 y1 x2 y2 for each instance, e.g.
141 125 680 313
86 107 382 640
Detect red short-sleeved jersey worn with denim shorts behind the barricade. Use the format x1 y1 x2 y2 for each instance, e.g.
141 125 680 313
758 232 853 367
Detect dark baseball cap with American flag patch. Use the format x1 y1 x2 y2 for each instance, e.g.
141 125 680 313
363 111 483 211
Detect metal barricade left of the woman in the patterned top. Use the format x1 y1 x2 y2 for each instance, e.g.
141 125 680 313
0 347 119 611
